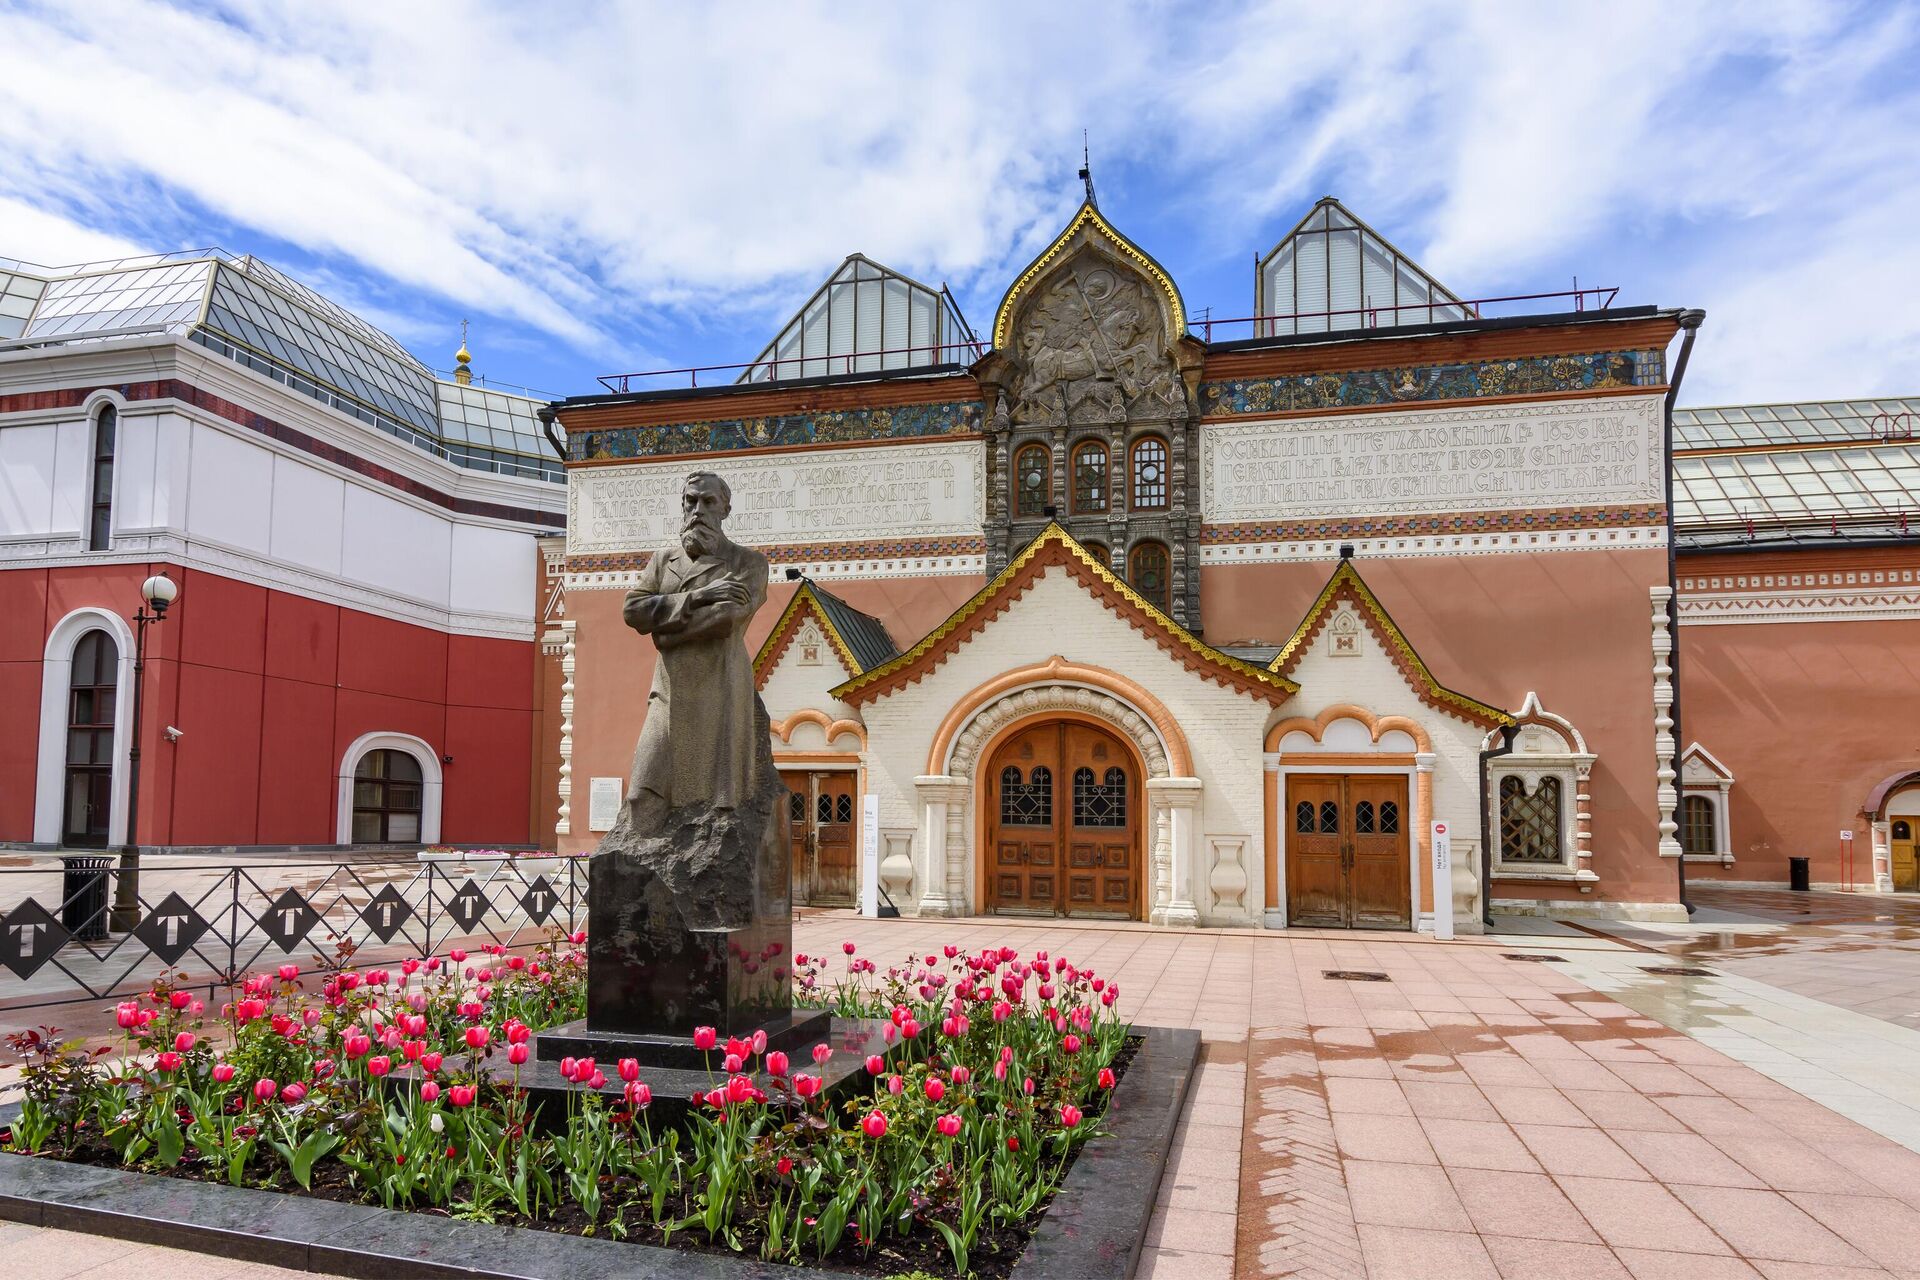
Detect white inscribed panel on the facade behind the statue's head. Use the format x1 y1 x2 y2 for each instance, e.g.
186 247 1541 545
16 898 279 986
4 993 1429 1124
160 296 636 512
566 439 987 555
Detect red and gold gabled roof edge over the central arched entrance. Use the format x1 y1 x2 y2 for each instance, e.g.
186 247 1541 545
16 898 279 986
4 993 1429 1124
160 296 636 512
833 524 1300 704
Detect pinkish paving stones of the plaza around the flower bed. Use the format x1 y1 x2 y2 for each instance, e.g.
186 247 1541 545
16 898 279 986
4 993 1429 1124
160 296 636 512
0 890 1920 1280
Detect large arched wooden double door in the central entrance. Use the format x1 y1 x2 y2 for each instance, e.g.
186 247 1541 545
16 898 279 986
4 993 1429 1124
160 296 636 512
987 722 1146 919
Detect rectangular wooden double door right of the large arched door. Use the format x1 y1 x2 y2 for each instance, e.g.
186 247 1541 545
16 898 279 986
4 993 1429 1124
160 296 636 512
1283 773 1413 929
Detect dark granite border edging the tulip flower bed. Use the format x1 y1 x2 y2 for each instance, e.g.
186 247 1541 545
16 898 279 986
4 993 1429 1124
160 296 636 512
0 1029 1200 1280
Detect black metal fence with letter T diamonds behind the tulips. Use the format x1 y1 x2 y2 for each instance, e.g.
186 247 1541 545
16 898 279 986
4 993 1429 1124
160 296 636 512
0 858 588 1009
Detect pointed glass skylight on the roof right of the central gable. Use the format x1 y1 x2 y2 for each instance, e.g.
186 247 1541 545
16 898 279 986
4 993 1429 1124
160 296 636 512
1254 196 1473 338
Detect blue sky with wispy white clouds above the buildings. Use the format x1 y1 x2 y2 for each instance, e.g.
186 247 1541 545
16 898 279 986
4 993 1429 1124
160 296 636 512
0 0 1920 405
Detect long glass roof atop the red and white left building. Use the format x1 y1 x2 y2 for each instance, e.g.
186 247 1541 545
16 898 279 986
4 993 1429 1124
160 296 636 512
0 249 563 482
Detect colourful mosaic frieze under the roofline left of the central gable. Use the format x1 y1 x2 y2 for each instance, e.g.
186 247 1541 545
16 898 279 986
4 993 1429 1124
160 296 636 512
566 401 981 462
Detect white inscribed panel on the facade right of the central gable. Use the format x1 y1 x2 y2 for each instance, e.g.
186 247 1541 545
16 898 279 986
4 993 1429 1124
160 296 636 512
1200 395 1665 524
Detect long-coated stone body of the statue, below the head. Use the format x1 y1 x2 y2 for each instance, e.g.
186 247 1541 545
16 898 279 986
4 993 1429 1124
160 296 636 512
622 541 766 837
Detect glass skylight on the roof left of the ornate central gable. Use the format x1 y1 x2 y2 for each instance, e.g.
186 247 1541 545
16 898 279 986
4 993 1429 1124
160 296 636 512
739 253 973 382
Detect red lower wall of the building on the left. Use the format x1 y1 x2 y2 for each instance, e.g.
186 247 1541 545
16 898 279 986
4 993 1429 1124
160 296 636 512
0 564 534 846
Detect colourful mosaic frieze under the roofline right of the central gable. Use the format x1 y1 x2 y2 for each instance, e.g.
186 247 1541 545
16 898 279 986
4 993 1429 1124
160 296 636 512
1200 347 1667 416
